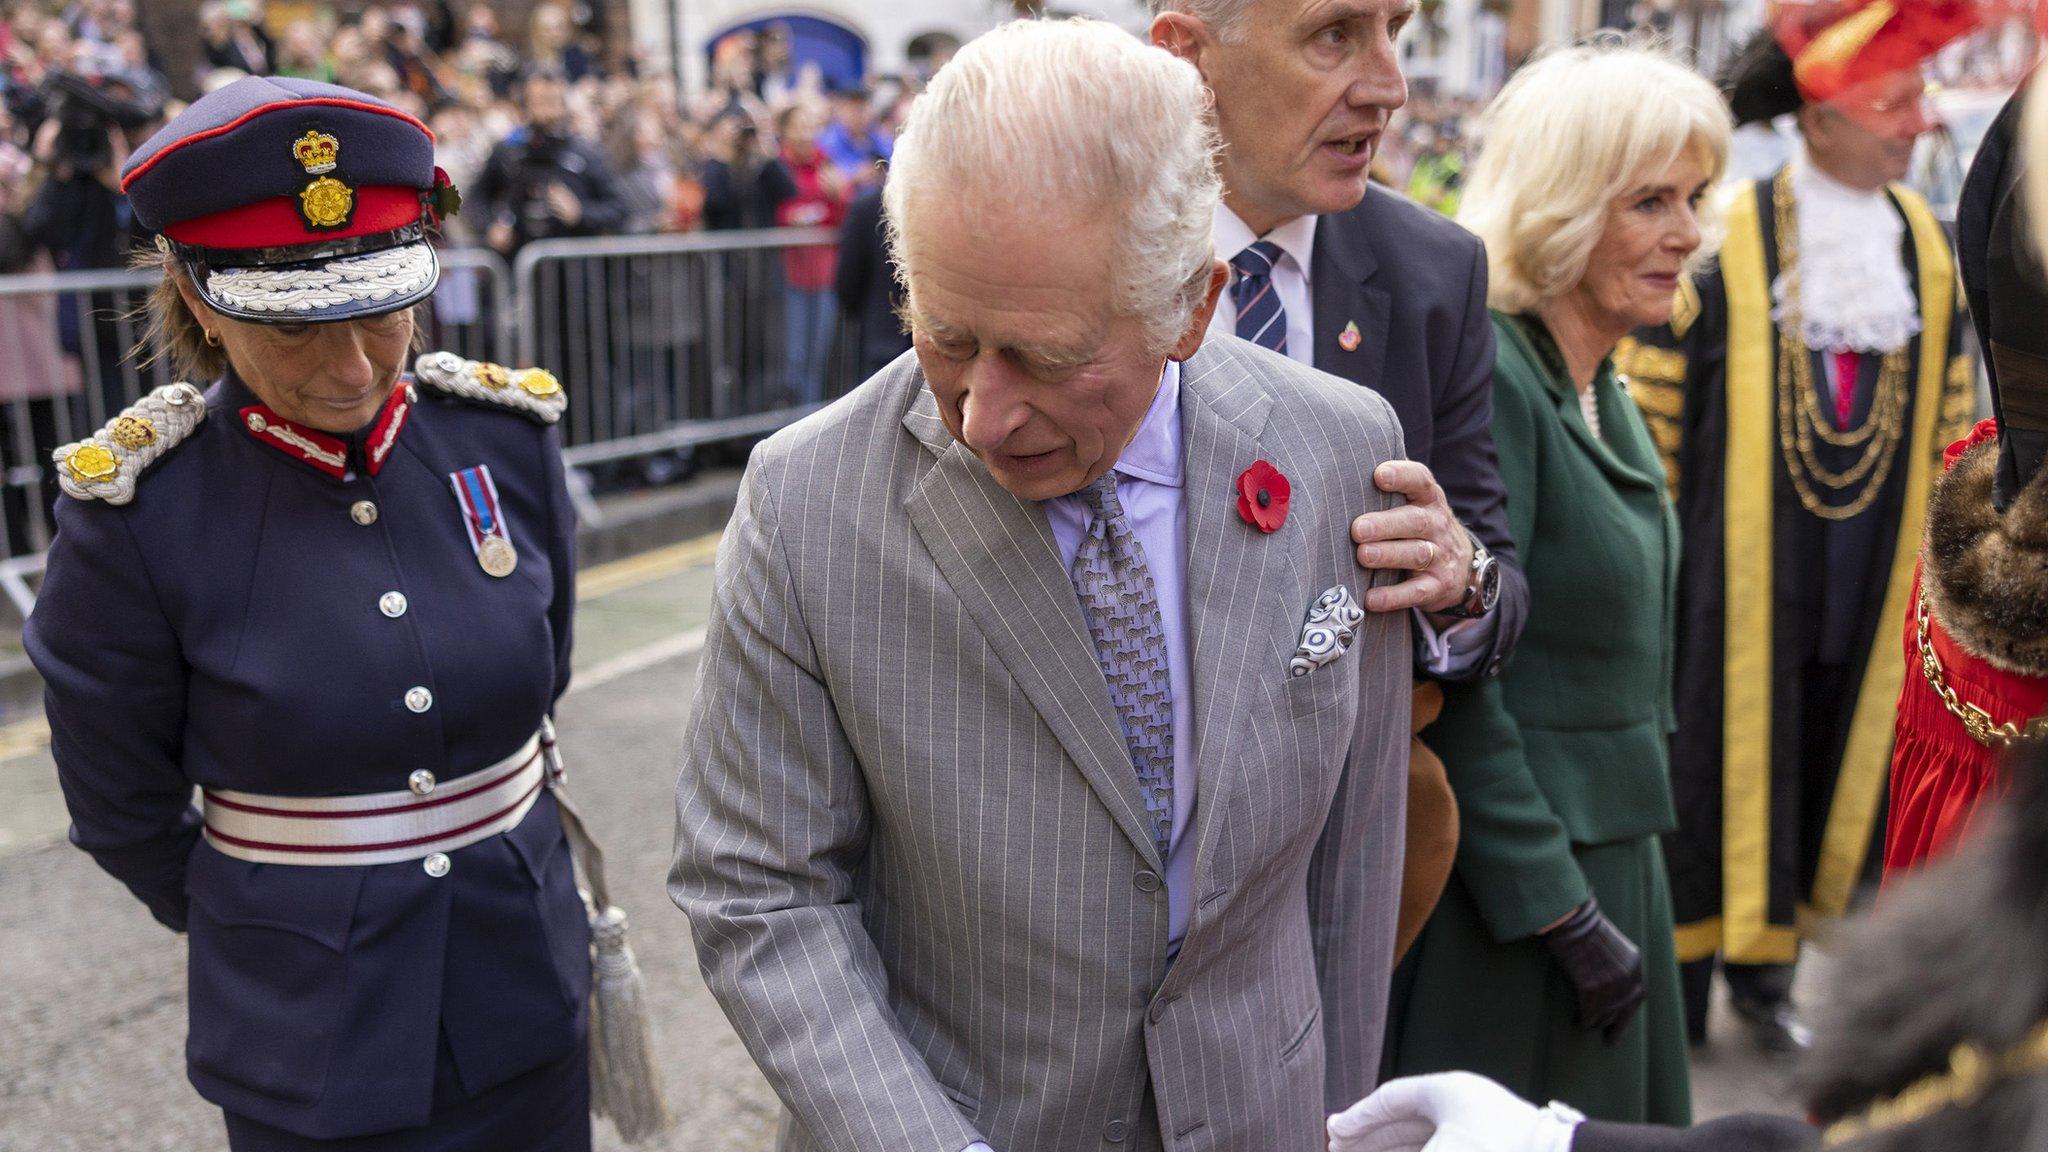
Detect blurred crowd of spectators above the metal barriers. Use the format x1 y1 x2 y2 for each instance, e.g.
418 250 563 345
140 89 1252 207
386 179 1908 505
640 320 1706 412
0 0 918 261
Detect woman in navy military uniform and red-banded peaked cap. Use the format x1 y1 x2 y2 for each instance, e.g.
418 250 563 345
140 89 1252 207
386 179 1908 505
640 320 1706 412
27 78 592 1152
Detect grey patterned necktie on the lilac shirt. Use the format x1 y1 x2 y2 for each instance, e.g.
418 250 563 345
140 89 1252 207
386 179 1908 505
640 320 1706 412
1073 471 1174 861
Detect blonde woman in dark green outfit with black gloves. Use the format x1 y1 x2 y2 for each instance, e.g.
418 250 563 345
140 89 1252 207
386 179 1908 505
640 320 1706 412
1386 43 1729 1123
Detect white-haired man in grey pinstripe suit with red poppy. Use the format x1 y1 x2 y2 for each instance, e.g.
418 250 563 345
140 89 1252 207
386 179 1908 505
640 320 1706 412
670 23 1411 1152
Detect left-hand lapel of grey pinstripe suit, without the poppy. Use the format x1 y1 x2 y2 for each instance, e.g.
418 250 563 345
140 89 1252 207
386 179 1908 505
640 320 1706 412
903 383 1163 869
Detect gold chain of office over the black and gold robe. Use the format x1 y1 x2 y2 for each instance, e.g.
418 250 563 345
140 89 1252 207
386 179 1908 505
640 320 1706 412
1772 168 1911 521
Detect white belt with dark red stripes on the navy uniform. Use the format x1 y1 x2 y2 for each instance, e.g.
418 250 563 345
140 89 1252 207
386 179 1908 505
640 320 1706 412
201 732 547 867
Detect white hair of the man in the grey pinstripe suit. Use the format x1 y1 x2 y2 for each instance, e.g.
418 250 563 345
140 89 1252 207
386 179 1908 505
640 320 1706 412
883 20 1223 353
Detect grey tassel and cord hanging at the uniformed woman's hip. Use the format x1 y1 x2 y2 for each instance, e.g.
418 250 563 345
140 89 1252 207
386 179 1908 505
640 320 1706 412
541 722 674 1144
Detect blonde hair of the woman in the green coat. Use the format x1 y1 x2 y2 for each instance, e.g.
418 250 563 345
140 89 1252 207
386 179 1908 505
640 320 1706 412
1458 37 1731 312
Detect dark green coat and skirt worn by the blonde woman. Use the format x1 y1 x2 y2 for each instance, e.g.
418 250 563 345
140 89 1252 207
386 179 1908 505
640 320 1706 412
1389 314 1690 1123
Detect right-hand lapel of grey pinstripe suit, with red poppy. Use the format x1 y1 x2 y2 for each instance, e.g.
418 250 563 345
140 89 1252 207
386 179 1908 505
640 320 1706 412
1180 340 1307 898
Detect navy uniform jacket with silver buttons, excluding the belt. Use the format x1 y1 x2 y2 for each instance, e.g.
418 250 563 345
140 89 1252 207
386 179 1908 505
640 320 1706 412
27 362 590 1138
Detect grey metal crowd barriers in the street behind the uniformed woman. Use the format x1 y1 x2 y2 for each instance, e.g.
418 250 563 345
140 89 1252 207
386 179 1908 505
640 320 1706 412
0 228 884 615
